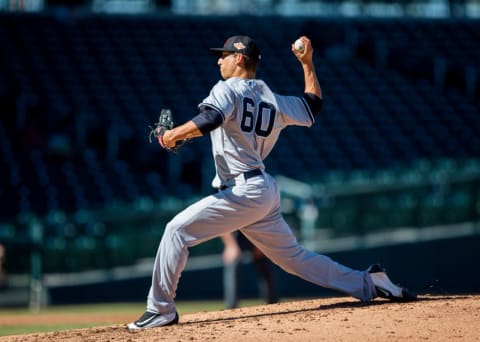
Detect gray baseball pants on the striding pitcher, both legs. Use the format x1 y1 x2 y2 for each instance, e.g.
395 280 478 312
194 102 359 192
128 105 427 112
147 172 375 313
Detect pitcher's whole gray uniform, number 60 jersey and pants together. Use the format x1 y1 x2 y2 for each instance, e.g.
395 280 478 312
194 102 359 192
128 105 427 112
147 78 375 314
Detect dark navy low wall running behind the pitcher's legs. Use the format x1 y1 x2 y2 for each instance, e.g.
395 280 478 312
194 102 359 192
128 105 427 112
44 234 480 304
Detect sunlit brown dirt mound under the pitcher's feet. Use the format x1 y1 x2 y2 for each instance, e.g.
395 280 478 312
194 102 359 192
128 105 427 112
3 295 480 342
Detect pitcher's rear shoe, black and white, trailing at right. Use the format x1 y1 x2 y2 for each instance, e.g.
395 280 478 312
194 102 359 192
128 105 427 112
368 264 417 302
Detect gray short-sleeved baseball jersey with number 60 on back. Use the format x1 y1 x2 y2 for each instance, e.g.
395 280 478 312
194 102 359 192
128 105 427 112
199 77 314 187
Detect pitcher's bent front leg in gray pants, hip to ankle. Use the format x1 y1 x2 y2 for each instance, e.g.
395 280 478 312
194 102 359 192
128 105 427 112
147 184 276 313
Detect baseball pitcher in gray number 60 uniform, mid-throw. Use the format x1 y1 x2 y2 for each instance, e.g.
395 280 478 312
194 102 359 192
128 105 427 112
127 36 415 330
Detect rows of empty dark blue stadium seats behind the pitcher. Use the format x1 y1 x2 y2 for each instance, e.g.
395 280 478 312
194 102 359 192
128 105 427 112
0 13 480 243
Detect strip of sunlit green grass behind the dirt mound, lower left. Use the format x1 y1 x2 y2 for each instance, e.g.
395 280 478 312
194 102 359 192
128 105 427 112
0 300 263 336
